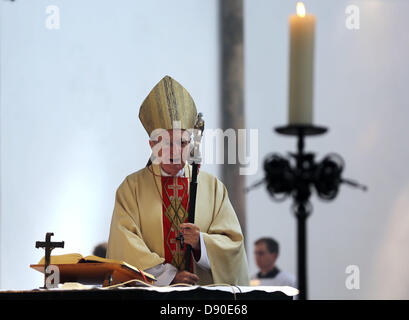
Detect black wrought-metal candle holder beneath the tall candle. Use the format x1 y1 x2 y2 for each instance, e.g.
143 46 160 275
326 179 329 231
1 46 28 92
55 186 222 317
247 125 367 300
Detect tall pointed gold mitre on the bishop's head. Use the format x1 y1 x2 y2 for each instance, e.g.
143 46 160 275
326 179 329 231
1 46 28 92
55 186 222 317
139 76 197 136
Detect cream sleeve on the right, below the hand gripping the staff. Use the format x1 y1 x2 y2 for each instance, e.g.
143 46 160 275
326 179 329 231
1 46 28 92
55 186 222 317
203 179 249 286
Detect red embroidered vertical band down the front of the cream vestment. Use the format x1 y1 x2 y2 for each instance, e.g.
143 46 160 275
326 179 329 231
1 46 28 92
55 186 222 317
161 176 193 272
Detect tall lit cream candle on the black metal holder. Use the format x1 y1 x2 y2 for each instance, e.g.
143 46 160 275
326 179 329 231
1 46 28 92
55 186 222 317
289 2 315 125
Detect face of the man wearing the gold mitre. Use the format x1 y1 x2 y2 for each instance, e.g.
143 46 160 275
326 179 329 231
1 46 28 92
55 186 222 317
149 129 190 175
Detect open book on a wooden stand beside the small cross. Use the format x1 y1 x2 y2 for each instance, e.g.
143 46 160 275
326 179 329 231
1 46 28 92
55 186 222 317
30 253 156 286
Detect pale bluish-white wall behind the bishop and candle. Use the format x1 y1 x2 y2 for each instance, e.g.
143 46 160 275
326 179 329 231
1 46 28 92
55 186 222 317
0 0 409 299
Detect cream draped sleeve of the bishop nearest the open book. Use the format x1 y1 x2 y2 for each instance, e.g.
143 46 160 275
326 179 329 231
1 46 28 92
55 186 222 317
107 178 164 270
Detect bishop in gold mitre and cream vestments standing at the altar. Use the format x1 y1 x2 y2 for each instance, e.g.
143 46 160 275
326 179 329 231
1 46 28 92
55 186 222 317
107 76 249 285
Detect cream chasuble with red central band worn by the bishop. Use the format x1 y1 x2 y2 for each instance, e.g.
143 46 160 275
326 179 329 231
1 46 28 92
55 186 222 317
107 165 249 285
